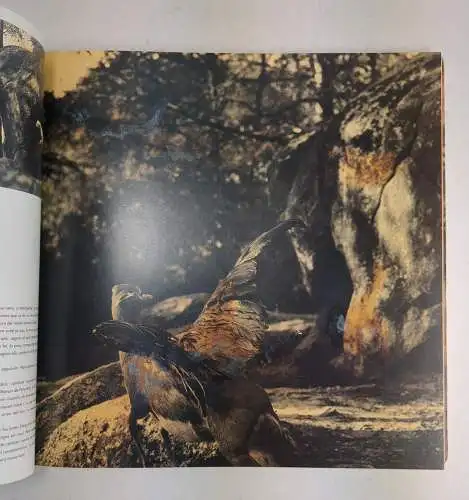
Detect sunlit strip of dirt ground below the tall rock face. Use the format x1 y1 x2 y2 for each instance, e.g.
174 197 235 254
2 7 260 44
268 381 444 469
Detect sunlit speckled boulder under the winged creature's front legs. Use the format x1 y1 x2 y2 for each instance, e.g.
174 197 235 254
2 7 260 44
36 396 227 467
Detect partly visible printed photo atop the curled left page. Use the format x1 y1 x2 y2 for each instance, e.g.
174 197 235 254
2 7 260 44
0 19 44 196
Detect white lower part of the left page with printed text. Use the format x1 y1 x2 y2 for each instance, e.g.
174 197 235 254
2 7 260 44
0 188 41 483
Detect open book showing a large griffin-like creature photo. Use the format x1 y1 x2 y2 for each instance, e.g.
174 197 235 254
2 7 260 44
0 11 446 482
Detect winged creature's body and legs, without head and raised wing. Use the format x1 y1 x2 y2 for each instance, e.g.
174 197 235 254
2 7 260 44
94 320 296 466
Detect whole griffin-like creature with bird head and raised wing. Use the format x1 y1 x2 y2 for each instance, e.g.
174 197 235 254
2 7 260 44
93 220 302 465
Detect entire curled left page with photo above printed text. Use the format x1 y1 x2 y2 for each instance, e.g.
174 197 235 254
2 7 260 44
0 10 43 483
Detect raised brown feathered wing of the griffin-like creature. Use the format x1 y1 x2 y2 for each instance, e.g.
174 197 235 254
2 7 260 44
178 219 304 374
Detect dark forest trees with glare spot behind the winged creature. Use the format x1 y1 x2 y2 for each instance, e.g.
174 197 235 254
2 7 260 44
39 52 413 379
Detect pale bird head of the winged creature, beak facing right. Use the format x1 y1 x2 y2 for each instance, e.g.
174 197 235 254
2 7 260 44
111 284 154 323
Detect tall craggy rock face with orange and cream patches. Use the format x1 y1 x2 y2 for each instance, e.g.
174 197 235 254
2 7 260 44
284 54 443 375
